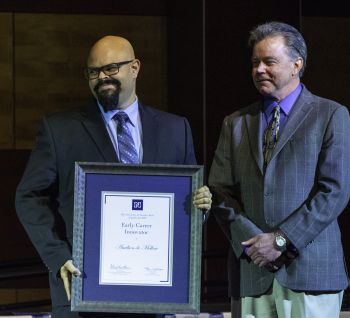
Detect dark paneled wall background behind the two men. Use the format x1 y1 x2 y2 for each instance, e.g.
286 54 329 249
0 0 350 310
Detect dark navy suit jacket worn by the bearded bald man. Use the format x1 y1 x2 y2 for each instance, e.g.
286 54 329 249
16 104 196 305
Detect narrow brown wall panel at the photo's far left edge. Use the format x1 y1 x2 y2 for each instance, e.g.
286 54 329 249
0 13 14 149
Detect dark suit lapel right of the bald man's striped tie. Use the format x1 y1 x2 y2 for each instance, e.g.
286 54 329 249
139 104 158 163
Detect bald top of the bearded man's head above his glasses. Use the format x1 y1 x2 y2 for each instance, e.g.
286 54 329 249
87 35 135 67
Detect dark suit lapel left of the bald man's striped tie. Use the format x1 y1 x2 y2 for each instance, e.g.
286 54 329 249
82 104 118 162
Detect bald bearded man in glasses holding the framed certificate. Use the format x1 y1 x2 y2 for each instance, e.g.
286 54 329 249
16 36 210 318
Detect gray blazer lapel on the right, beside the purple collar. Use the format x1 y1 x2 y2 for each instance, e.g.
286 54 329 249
271 86 313 160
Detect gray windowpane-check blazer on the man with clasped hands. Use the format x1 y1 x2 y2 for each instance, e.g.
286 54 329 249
209 87 350 296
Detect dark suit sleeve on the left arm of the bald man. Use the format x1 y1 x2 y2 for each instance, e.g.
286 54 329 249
16 119 72 274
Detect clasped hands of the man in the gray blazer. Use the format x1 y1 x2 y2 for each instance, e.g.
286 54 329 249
242 233 282 267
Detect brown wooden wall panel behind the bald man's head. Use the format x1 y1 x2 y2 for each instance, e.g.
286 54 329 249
14 13 167 149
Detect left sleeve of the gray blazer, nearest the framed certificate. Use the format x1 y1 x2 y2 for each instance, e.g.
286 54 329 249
209 117 263 257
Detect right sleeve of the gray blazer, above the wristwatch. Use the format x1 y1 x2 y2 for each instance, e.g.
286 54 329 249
280 107 350 249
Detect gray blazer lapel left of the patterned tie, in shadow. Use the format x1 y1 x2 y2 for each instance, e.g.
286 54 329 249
245 102 264 173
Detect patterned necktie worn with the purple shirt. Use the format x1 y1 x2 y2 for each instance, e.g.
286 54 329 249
264 104 280 167
